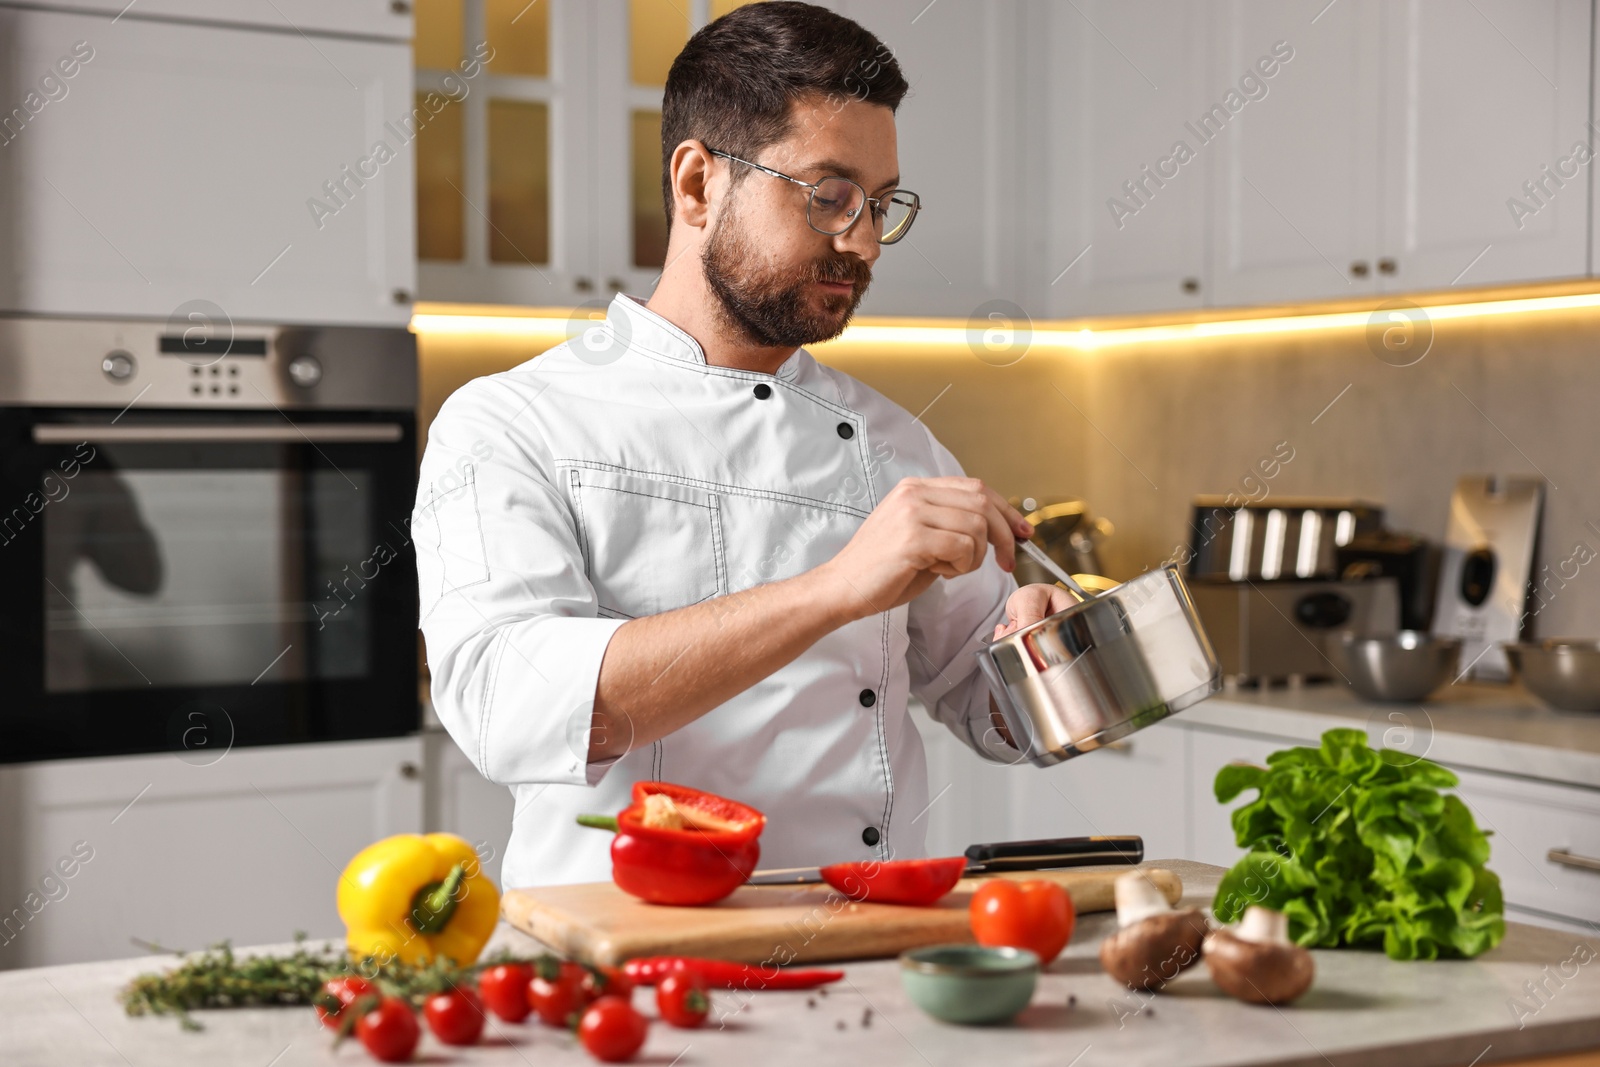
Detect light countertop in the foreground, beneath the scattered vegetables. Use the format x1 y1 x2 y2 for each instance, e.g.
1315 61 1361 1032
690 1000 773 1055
0 861 1600 1067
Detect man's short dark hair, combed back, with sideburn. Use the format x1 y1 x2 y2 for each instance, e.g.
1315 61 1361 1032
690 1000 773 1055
661 0 910 224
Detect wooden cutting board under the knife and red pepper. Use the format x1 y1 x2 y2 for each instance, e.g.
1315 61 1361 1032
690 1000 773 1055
501 865 1182 966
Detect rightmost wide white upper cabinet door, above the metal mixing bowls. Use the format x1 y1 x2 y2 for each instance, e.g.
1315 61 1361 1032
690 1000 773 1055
1376 0 1594 291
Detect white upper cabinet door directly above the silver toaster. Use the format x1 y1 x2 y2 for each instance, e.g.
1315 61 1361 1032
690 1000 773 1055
1203 0 1382 306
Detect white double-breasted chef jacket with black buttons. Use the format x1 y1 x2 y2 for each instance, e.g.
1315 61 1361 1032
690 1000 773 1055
413 289 1016 886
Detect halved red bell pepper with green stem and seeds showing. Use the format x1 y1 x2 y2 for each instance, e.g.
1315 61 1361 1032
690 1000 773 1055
578 782 766 904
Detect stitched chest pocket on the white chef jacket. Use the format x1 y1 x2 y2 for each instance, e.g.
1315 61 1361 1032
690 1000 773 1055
566 467 728 619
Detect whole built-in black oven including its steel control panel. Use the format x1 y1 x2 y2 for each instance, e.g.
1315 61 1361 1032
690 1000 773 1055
0 318 419 763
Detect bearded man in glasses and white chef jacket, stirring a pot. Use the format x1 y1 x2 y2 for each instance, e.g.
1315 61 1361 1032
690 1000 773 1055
414 0 1070 885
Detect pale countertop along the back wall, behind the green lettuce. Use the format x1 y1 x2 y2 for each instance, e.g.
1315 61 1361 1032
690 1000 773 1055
1178 685 1600 789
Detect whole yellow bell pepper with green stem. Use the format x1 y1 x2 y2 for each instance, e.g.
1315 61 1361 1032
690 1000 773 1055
339 833 499 966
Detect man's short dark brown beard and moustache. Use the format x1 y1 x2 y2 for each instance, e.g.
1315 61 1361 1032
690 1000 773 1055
701 214 872 349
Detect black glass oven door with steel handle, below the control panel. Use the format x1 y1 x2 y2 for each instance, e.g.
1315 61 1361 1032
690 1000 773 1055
0 408 419 761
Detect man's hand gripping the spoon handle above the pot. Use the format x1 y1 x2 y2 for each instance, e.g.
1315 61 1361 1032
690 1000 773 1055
822 478 1034 617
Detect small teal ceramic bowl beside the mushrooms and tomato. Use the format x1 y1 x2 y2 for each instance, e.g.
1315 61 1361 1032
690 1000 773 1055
901 945 1038 1024
